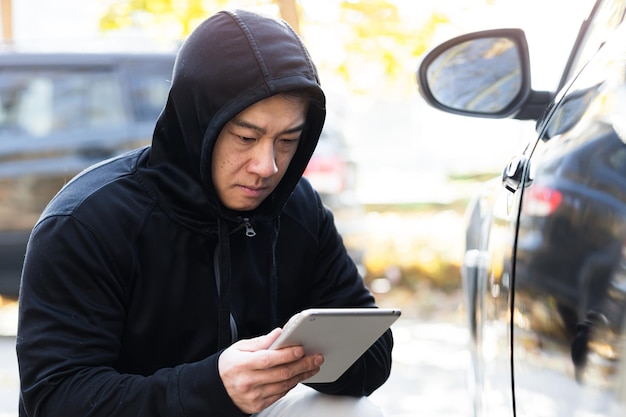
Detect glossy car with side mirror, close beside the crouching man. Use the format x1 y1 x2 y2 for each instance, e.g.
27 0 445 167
417 0 626 417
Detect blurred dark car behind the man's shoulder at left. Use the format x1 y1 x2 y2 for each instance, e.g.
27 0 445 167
0 51 174 297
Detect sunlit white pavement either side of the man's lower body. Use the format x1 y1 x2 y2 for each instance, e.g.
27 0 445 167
0 302 470 417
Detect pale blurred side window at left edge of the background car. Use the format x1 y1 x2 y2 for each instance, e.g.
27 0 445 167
0 68 128 140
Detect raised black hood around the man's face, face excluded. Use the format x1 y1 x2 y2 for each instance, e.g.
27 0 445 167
148 11 326 223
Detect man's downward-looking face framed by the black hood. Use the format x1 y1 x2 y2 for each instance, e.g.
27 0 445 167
212 95 308 211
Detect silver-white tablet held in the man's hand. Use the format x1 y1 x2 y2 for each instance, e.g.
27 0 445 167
270 308 401 383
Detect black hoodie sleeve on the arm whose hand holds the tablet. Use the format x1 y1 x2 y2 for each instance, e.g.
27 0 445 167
16 216 244 417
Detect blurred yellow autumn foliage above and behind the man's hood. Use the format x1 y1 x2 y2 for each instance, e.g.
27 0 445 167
100 0 447 94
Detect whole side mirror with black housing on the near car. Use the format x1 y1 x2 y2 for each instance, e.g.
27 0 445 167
417 29 553 120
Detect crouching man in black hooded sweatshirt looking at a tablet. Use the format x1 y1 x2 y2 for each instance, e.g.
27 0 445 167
17 11 393 417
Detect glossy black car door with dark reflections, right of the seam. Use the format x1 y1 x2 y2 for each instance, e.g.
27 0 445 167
510 0 626 417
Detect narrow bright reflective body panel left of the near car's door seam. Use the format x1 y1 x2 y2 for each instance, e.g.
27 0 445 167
462 179 514 416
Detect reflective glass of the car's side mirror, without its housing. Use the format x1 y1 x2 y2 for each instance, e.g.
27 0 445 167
426 37 522 113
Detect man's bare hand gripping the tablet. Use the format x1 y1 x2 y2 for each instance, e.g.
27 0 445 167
218 329 324 414
